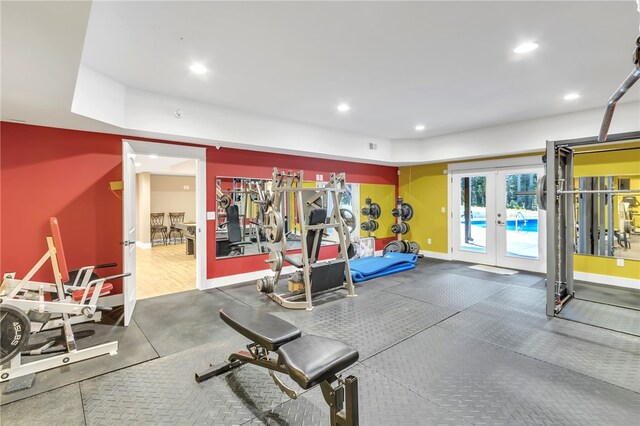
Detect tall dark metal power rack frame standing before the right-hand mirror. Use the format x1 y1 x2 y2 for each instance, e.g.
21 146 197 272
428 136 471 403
537 132 640 317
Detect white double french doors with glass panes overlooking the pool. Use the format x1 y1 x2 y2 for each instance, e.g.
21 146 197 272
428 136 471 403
450 167 546 272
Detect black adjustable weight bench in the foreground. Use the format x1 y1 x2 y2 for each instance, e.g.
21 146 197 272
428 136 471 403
195 306 359 426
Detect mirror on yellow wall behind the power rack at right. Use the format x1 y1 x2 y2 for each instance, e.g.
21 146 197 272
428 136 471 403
574 175 640 260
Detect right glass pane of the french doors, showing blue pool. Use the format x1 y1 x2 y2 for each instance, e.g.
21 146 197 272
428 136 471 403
499 172 540 259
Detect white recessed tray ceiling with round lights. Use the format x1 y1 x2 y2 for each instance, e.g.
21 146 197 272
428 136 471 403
82 0 640 139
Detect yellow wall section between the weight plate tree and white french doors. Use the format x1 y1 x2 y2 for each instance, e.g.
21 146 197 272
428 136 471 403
399 163 449 253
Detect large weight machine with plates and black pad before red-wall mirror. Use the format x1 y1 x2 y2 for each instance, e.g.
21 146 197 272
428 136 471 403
256 168 355 310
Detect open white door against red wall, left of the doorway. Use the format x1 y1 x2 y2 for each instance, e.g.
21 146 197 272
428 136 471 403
122 142 136 326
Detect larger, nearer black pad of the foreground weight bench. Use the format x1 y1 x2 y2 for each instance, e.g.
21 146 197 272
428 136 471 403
278 335 359 389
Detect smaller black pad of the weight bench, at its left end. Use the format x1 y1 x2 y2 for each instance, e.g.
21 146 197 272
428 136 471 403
220 306 302 351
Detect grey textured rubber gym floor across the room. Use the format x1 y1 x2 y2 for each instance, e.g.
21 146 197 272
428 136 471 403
0 259 640 425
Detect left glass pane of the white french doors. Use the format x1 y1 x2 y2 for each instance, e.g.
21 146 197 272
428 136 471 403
458 176 487 253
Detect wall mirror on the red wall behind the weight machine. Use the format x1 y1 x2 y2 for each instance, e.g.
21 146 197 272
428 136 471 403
216 176 359 258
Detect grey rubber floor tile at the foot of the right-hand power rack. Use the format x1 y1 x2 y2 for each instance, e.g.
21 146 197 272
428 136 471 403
558 299 640 337
